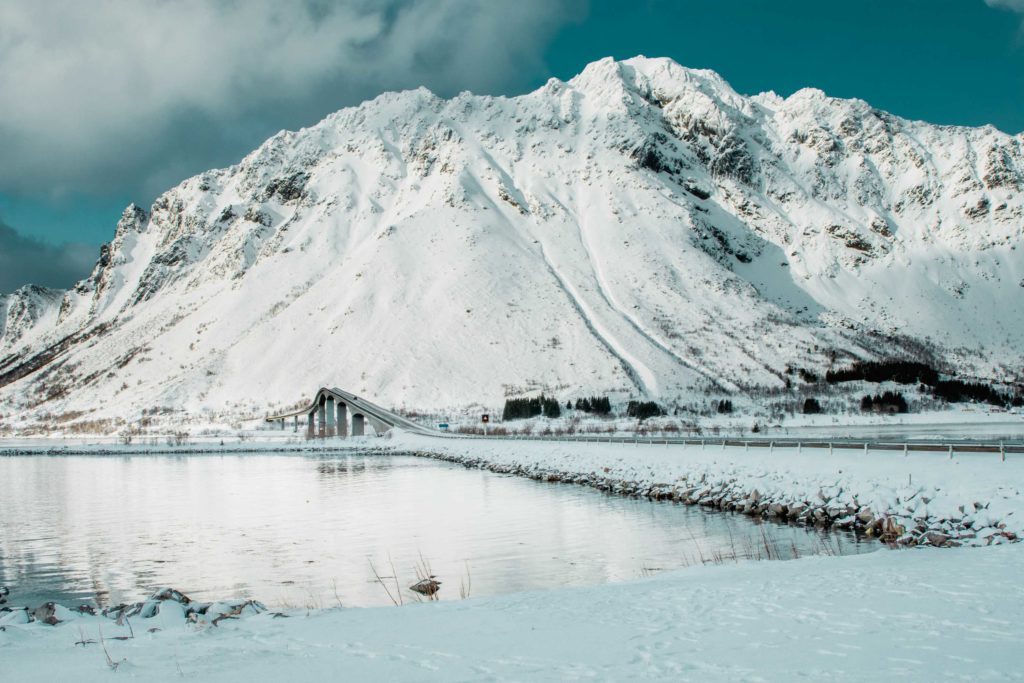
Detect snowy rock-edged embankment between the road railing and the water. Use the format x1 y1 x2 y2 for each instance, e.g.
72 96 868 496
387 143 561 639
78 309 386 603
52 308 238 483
390 433 1024 546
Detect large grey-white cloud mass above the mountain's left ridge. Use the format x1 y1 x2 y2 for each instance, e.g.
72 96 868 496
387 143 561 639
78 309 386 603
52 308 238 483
0 0 580 194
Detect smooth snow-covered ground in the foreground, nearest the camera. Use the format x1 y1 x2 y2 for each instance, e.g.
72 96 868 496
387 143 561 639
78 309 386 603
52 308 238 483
0 544 1024 683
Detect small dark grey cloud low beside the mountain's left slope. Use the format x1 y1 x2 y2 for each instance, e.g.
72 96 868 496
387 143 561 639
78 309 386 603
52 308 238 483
0 222 99 294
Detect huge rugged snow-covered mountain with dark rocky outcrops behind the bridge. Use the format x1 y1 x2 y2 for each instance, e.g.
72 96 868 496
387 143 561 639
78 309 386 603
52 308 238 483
0 57 1024 423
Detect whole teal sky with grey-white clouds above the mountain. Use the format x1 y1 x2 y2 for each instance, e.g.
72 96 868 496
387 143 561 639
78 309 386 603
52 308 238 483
0 0 1024 293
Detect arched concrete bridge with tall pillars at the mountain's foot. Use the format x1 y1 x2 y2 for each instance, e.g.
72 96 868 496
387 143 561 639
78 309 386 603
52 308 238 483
266 387 440 438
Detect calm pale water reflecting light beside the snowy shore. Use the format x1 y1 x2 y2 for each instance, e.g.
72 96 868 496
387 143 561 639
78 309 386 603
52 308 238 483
0 454 878 606
